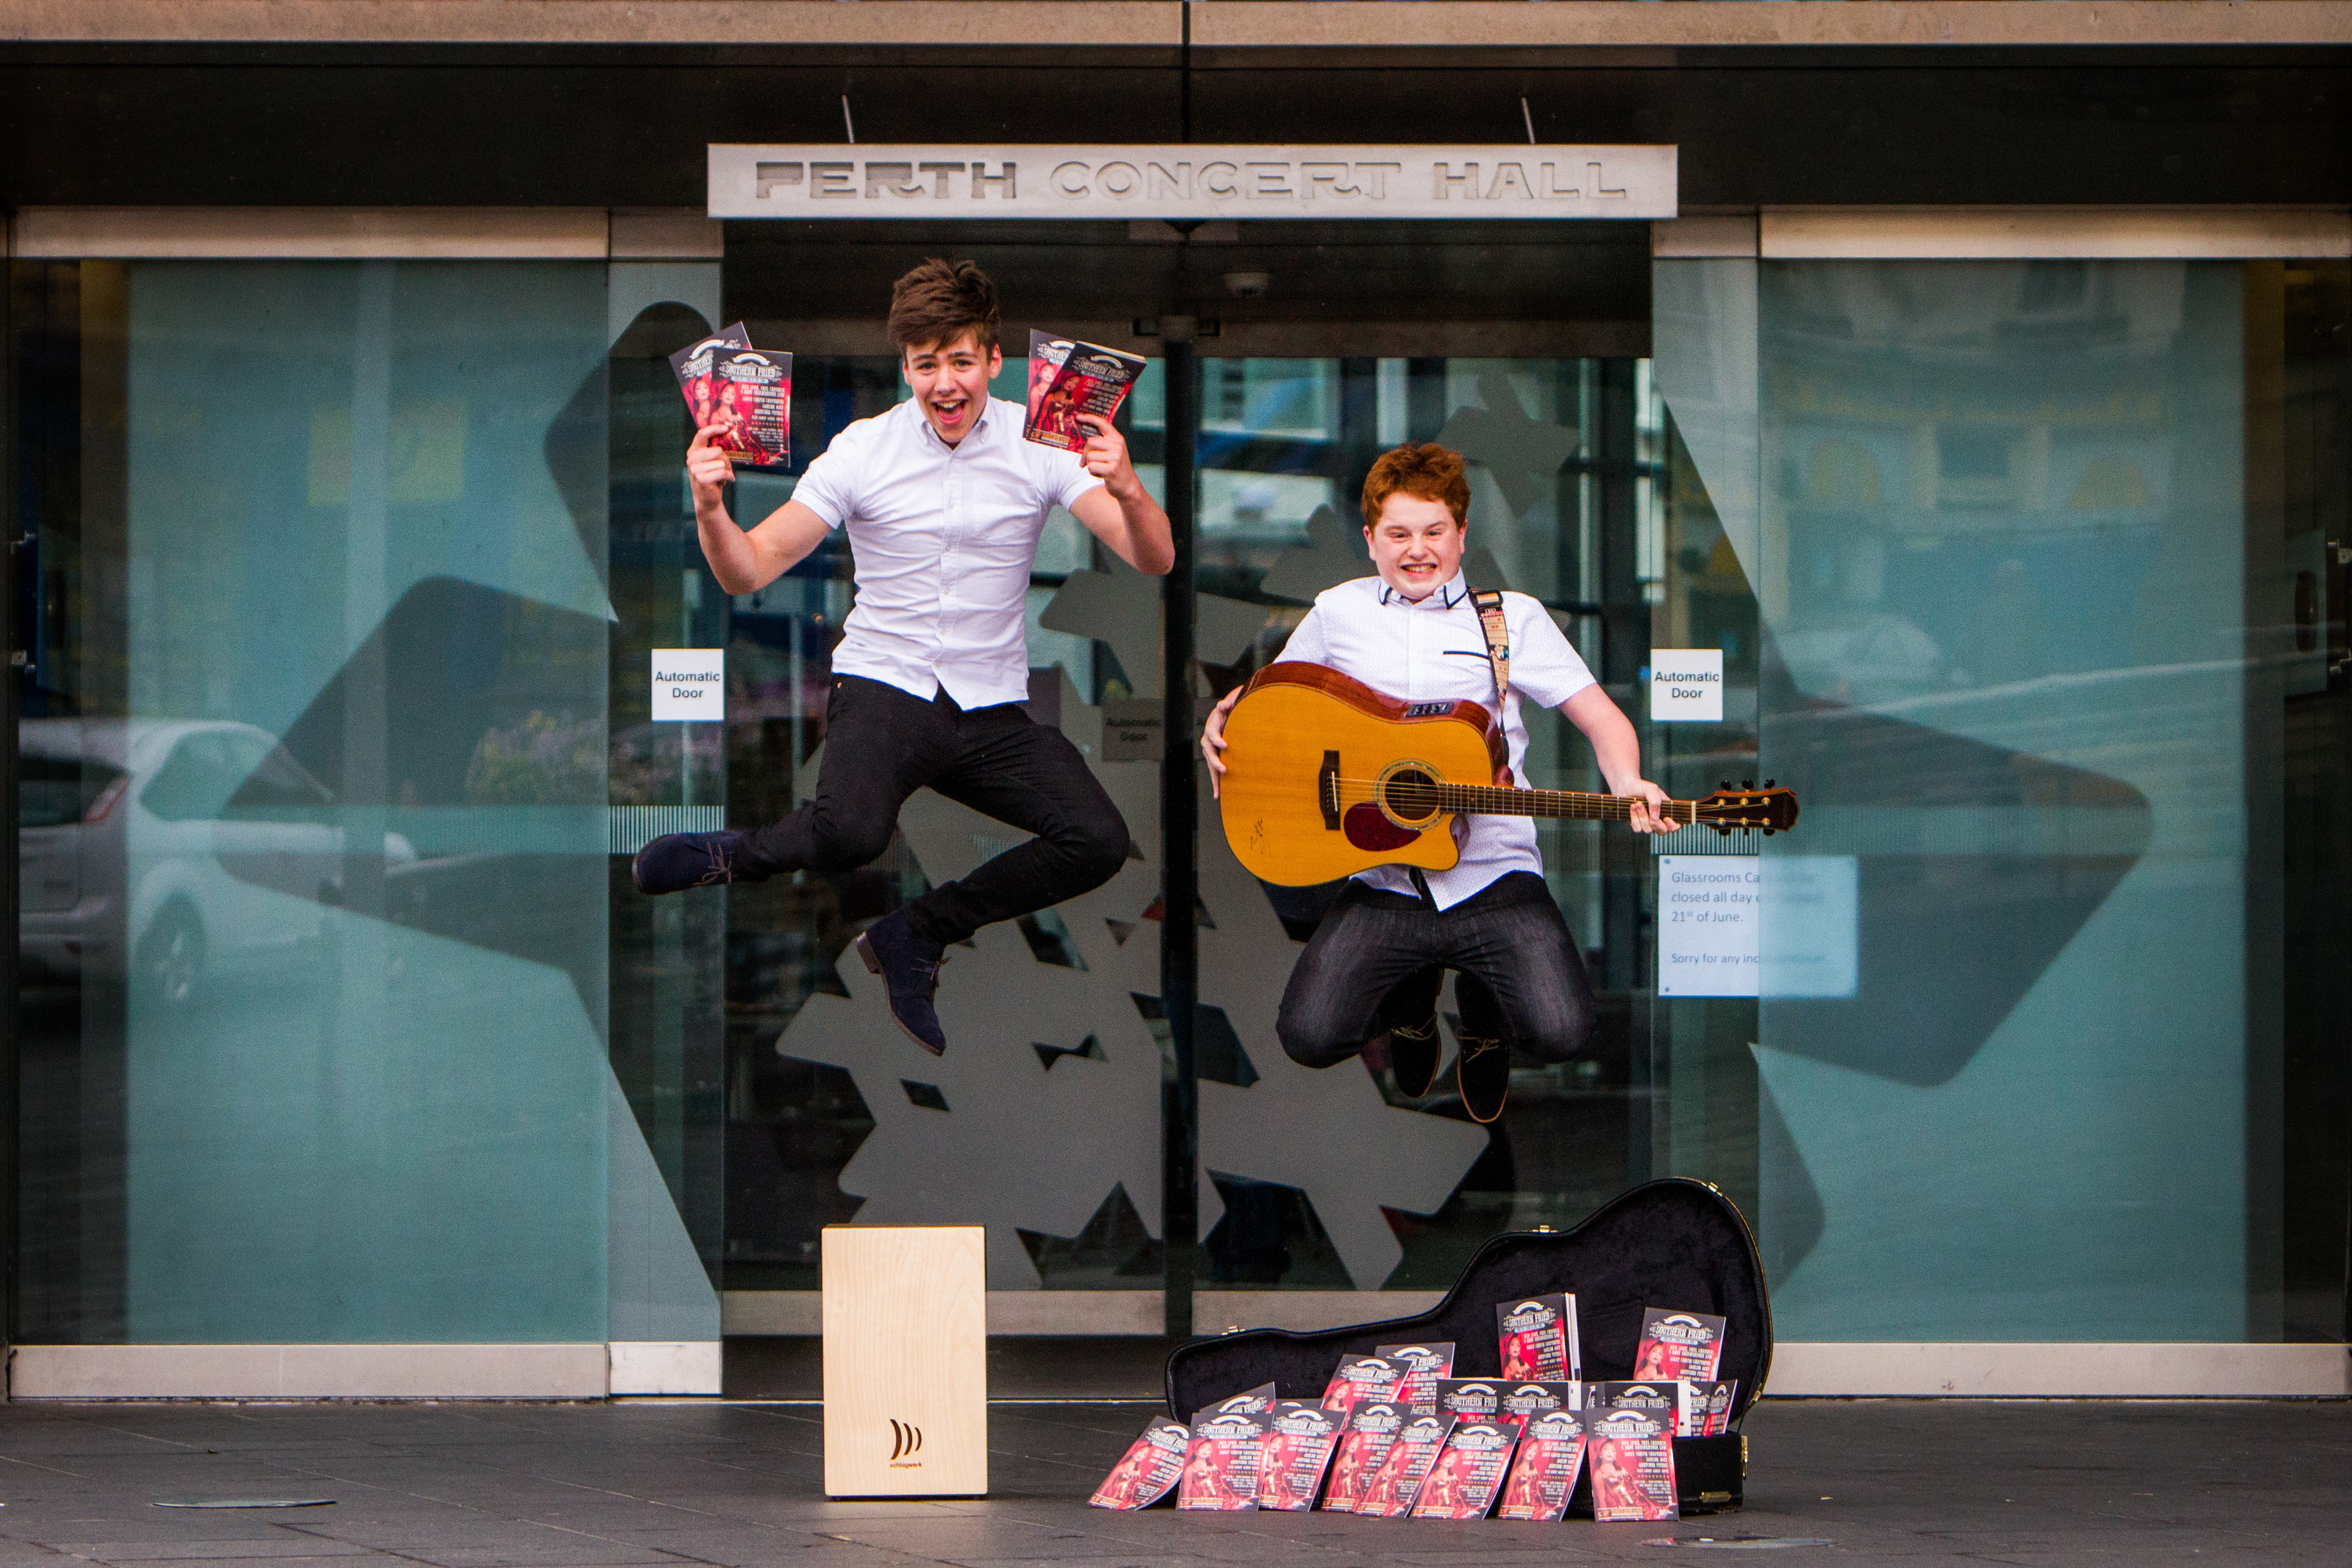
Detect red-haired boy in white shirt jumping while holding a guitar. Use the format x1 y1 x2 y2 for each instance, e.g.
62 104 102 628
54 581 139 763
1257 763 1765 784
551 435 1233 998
1200 442 1689 1122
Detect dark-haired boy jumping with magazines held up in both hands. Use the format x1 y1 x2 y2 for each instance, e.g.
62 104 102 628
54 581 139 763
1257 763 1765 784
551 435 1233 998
630 261 1176 1055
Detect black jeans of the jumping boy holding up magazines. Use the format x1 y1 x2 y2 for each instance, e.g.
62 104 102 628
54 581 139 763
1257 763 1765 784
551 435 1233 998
736 674 1126 943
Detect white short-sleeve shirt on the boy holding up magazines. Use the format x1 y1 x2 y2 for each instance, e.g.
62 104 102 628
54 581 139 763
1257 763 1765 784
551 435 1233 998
793 397 1101 708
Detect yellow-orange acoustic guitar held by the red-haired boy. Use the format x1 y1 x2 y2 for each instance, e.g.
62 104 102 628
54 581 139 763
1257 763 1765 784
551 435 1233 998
1221 661 1797 886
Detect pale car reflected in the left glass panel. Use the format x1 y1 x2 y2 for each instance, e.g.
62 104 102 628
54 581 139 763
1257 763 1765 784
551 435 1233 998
17 719 416 1006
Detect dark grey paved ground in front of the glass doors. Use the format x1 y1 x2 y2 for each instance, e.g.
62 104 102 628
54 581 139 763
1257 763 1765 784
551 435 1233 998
0 1401 2352 1568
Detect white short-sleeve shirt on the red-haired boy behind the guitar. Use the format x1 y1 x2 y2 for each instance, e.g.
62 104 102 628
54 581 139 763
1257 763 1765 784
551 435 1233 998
1282 573 1592 910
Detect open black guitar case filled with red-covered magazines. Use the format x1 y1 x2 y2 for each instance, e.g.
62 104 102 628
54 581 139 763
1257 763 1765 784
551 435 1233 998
1167 1177 1771 1519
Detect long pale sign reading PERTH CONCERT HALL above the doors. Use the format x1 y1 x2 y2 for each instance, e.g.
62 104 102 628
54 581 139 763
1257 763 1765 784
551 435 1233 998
710 144 1677 221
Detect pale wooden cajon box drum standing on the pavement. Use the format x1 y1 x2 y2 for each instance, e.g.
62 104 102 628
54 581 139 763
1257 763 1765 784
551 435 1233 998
823 1225 988 1498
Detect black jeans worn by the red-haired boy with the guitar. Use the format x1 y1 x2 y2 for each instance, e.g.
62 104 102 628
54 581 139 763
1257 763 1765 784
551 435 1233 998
1275 872 1592 1067
